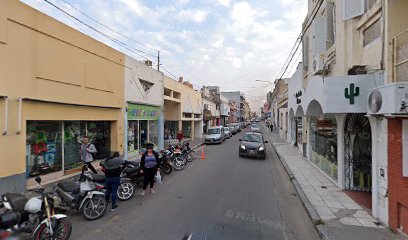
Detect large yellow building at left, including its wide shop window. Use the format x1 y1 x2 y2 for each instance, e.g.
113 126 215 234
0 0 125 192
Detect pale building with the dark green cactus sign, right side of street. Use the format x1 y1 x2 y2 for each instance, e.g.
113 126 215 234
287 0 408 231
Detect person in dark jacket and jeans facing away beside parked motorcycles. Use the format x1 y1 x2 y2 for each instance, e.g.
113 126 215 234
101 152 126 211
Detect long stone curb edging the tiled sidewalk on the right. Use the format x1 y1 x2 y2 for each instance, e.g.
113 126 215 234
269 131 332 240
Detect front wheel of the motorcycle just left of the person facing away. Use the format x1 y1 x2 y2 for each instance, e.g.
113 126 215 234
82 195 108 221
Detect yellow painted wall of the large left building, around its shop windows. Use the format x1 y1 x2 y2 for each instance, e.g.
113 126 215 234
0 0 124 186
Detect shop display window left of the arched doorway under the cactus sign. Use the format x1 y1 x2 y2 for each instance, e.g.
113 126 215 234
310 114 337 180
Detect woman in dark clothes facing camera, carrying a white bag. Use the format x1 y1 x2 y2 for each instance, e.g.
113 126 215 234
140 143 160 196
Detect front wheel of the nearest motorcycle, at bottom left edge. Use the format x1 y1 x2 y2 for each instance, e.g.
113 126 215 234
34 218 72 240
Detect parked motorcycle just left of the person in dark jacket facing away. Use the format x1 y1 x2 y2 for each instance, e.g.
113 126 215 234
53 166 108 221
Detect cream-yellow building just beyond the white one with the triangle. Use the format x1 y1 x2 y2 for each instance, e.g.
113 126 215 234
164 76 203 142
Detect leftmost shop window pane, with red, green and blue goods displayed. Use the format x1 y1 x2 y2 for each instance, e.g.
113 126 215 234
26 121 62 177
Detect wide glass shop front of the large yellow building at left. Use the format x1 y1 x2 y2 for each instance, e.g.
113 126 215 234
26 121 111 177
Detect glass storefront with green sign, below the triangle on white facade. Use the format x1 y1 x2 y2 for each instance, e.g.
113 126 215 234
127 103 160 156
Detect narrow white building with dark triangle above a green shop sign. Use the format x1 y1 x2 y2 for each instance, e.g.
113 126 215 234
124 56 164 159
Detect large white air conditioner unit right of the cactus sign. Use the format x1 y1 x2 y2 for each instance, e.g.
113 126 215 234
367 83 408 116
